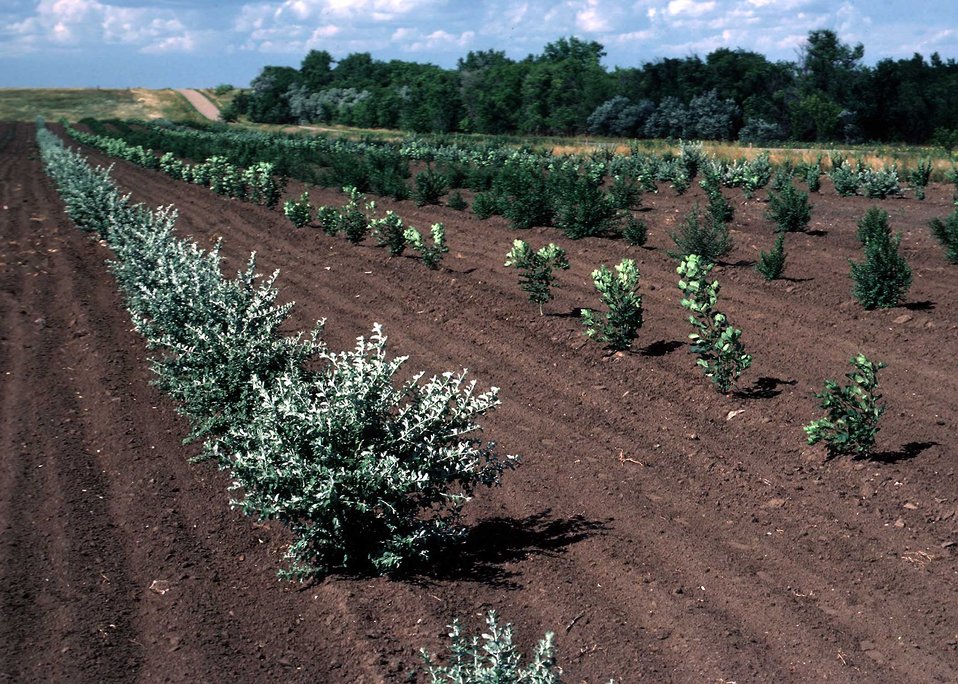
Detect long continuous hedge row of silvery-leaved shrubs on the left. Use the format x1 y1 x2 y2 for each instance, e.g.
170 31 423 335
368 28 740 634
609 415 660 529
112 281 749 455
37 120 516 577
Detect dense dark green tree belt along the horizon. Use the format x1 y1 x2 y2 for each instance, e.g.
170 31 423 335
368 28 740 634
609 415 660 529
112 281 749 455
224 29 958 147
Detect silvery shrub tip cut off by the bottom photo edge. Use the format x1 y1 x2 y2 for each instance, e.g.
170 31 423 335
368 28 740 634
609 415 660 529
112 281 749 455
420 610 561 684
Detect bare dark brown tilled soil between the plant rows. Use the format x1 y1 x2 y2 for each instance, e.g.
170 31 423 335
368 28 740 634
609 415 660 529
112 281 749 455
0 124 958 682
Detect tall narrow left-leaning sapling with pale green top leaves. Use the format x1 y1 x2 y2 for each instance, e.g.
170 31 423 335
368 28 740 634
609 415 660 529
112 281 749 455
676 254 752 394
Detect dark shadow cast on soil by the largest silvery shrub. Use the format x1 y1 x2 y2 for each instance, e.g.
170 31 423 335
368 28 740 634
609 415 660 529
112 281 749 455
409 509 612 589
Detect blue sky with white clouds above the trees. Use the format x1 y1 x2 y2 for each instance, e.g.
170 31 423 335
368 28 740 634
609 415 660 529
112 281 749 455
0 0 958 88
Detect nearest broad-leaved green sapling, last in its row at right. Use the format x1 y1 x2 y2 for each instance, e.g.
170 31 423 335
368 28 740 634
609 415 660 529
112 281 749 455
804 354 885 456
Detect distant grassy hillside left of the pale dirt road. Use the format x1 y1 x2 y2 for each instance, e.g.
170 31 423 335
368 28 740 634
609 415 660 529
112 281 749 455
0 88 204 121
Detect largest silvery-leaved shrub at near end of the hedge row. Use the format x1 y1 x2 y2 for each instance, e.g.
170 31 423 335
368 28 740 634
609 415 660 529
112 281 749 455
228 325 515 576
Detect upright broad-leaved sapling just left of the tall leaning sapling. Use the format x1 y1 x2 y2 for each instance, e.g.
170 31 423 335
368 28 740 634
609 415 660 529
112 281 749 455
582 259 642 351
